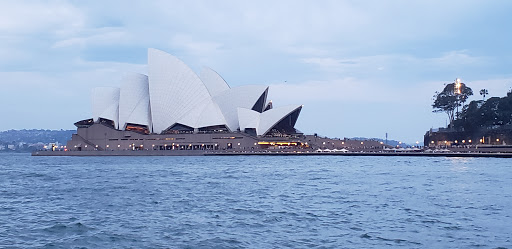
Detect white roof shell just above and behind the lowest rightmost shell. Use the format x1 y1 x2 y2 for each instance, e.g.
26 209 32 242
213 85 268 131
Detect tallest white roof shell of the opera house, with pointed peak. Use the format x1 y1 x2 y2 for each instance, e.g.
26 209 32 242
148 49 210 133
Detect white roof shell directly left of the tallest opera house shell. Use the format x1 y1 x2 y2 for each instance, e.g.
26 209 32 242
119 73 151 130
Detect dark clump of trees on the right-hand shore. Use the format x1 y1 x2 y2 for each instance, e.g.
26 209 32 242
423 79 512 149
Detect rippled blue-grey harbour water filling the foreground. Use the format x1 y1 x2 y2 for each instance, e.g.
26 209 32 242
0 154 512 248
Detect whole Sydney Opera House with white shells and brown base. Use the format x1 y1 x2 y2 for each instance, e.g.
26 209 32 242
66 49 307 154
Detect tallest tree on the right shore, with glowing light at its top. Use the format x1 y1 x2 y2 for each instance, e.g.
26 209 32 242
432 79 473 126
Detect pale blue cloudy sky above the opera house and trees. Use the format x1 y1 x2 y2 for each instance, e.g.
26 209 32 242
0 0 512 142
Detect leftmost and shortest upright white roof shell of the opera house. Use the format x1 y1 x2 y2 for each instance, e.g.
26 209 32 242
91 87 119 128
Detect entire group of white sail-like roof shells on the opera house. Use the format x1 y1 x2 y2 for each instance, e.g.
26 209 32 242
83 49 301 135
